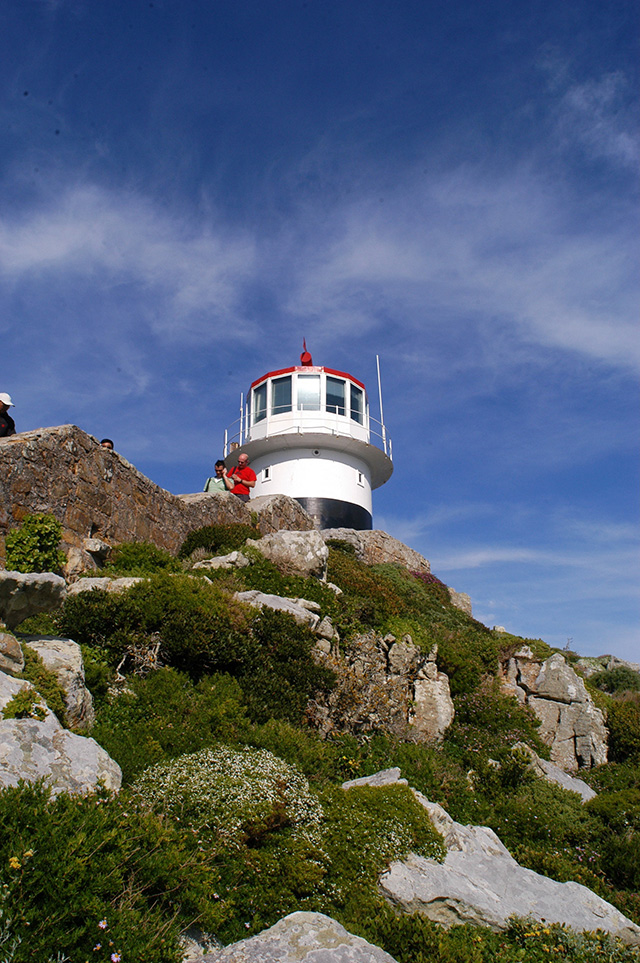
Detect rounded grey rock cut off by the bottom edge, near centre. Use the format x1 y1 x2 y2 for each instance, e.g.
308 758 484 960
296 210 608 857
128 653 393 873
200 913 396 963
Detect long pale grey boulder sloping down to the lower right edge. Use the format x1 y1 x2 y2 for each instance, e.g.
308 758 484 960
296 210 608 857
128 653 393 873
380 792 640 945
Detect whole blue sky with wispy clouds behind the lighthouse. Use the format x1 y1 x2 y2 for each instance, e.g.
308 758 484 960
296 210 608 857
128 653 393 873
0 0 640 661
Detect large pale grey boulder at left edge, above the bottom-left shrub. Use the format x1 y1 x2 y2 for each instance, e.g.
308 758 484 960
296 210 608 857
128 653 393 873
0 673 122 794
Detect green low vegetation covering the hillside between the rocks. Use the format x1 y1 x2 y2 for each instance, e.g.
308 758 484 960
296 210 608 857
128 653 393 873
5 526 640 963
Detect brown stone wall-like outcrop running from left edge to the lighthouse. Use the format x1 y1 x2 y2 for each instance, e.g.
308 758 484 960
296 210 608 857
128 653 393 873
0 425 313 560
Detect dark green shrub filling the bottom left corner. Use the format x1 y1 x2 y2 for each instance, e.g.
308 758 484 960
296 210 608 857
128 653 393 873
0 783 222 963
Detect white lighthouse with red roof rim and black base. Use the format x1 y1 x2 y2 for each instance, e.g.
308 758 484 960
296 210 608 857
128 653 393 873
224 343 393 530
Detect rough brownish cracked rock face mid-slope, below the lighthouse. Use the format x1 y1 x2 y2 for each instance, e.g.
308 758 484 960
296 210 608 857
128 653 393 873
307 632 454 742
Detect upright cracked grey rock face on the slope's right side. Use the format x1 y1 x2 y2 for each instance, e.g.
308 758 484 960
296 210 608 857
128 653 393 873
501 645 607 772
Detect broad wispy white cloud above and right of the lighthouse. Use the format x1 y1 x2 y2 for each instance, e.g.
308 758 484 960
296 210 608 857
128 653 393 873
287 158 640 368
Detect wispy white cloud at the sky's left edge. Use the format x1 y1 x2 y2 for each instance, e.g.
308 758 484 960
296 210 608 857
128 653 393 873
0 185 255 341
